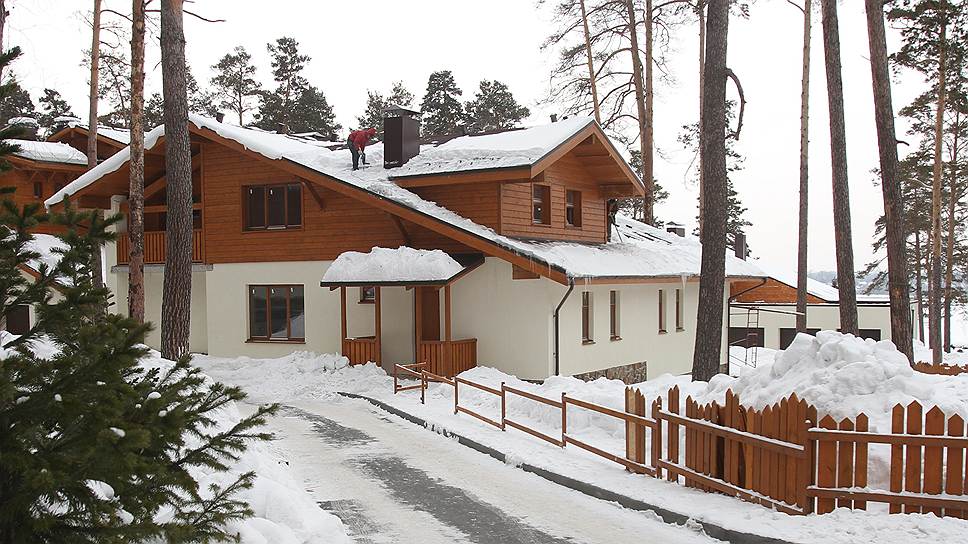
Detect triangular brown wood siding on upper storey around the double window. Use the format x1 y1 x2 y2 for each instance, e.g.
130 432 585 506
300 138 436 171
202 142 470 264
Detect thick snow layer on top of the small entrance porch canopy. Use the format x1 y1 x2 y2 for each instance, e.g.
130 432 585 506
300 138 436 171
323 246 464 284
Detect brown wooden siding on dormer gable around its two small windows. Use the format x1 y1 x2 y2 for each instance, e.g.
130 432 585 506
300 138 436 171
500 154 606 242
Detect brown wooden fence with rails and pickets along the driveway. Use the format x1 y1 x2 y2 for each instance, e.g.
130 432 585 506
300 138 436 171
394 374 968 519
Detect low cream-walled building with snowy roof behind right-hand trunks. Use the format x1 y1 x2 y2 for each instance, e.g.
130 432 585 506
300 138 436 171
728 268 917 349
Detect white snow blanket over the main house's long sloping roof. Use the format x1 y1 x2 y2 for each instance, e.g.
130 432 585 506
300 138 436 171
47 114 764 280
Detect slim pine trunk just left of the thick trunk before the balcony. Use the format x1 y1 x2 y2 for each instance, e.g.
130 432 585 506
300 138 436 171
128 0 145 323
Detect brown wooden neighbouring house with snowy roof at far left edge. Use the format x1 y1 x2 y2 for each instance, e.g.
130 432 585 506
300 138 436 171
0 139 87 233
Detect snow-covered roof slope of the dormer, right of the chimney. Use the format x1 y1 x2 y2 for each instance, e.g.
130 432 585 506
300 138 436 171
391 117 595 179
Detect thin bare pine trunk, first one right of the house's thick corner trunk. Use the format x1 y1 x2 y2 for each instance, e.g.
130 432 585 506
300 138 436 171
797 0 812 332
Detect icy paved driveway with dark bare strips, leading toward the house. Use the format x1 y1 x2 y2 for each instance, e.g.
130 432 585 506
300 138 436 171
258 398 716 544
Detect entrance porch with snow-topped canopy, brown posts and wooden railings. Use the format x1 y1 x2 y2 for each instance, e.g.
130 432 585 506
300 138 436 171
319 246 484 376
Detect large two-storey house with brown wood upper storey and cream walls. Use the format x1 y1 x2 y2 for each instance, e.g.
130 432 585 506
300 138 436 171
47 110 762 380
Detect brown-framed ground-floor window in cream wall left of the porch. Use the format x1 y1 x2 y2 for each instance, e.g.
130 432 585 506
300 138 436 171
249 285 306 342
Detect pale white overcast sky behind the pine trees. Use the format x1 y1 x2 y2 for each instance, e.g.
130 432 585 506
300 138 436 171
4 0 922 271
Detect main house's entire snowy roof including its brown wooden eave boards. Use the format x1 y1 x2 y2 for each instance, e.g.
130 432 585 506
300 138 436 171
46 114 764 284
